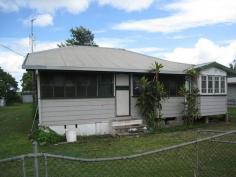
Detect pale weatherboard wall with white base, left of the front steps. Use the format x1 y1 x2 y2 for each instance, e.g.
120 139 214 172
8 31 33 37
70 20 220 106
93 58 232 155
41 98 115 135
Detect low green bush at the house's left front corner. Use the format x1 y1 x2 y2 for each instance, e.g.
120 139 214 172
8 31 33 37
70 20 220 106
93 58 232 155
35 127 65 145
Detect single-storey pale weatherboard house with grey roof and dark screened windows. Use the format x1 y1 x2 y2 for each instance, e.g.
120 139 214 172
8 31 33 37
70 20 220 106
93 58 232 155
23 46 232 135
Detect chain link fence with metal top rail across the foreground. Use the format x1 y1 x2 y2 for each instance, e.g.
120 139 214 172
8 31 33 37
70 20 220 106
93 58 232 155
0 130 236 177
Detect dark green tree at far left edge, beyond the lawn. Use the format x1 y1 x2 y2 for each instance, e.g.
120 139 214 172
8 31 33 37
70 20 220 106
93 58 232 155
0 67 18 104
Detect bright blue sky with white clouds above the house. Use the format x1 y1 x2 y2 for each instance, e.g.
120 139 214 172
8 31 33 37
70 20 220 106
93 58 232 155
0 0 236 88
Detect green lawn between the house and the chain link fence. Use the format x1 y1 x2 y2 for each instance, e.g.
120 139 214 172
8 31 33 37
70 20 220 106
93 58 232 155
0 104 236 158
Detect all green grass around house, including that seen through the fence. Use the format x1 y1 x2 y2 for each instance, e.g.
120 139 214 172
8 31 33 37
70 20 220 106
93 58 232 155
0 104 236 177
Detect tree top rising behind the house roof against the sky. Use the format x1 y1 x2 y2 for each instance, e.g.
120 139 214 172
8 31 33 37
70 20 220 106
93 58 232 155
57 26 98 47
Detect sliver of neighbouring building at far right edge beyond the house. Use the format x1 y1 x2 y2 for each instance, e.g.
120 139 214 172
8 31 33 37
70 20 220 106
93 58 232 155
227 77 236 106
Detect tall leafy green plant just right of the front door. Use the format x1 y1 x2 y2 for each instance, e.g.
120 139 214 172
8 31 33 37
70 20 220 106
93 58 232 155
137 62 167 129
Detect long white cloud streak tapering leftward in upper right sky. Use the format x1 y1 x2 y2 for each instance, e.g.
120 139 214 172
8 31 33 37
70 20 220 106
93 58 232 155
113 0 236 33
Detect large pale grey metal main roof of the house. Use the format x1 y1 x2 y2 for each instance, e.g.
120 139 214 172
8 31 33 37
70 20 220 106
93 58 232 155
22 46 193 74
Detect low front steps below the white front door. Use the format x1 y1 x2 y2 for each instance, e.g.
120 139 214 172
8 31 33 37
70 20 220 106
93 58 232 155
112 117 146 136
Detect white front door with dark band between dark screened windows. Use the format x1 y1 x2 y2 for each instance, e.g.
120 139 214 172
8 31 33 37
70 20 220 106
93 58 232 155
116 74 130 116
